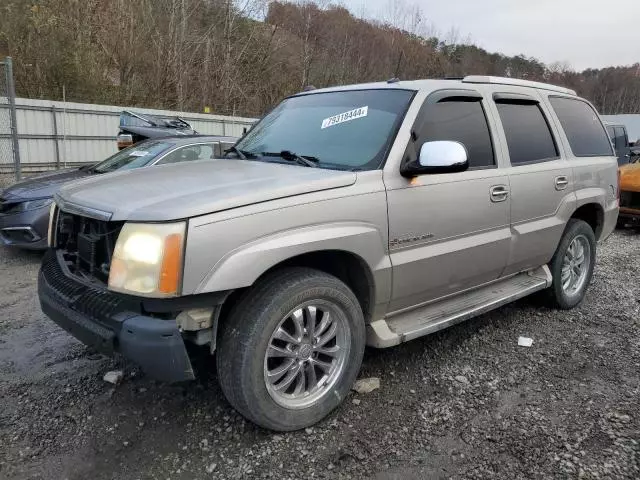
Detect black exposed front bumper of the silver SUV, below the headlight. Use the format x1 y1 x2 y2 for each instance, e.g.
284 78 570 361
38 252 195 382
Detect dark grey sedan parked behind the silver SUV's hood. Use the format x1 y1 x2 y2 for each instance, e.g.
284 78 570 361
0 136 236 250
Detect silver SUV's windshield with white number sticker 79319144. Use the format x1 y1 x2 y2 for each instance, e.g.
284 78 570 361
236 89 414 170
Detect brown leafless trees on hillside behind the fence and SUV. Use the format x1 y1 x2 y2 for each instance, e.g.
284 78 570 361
0 0 640 116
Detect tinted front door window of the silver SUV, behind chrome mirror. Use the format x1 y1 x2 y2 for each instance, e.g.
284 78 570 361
419 97 495 168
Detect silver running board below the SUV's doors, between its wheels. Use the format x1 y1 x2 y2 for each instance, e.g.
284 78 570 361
367 265 551 348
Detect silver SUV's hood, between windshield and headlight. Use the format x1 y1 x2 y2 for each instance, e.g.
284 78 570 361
56 159 356 221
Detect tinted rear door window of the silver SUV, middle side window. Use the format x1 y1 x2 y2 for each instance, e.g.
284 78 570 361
496 101 558 165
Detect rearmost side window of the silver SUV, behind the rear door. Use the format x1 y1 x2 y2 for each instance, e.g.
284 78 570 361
549 97 613 157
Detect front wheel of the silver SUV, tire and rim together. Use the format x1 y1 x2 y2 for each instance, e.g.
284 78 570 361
217 268 365 431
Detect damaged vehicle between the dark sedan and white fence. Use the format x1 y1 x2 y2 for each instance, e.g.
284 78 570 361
118 110 197 150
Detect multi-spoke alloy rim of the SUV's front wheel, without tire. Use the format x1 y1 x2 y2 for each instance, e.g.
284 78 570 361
264 300 351 409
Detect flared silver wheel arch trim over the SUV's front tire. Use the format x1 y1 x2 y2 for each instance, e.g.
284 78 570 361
196 222 391 301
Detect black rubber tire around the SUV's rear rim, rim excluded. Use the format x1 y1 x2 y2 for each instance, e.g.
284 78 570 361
550 219 597 309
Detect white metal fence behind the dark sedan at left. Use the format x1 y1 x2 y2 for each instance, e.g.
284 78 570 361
0 98 255 172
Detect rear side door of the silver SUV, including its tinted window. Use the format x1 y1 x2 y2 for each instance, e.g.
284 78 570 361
493 92 573 275
